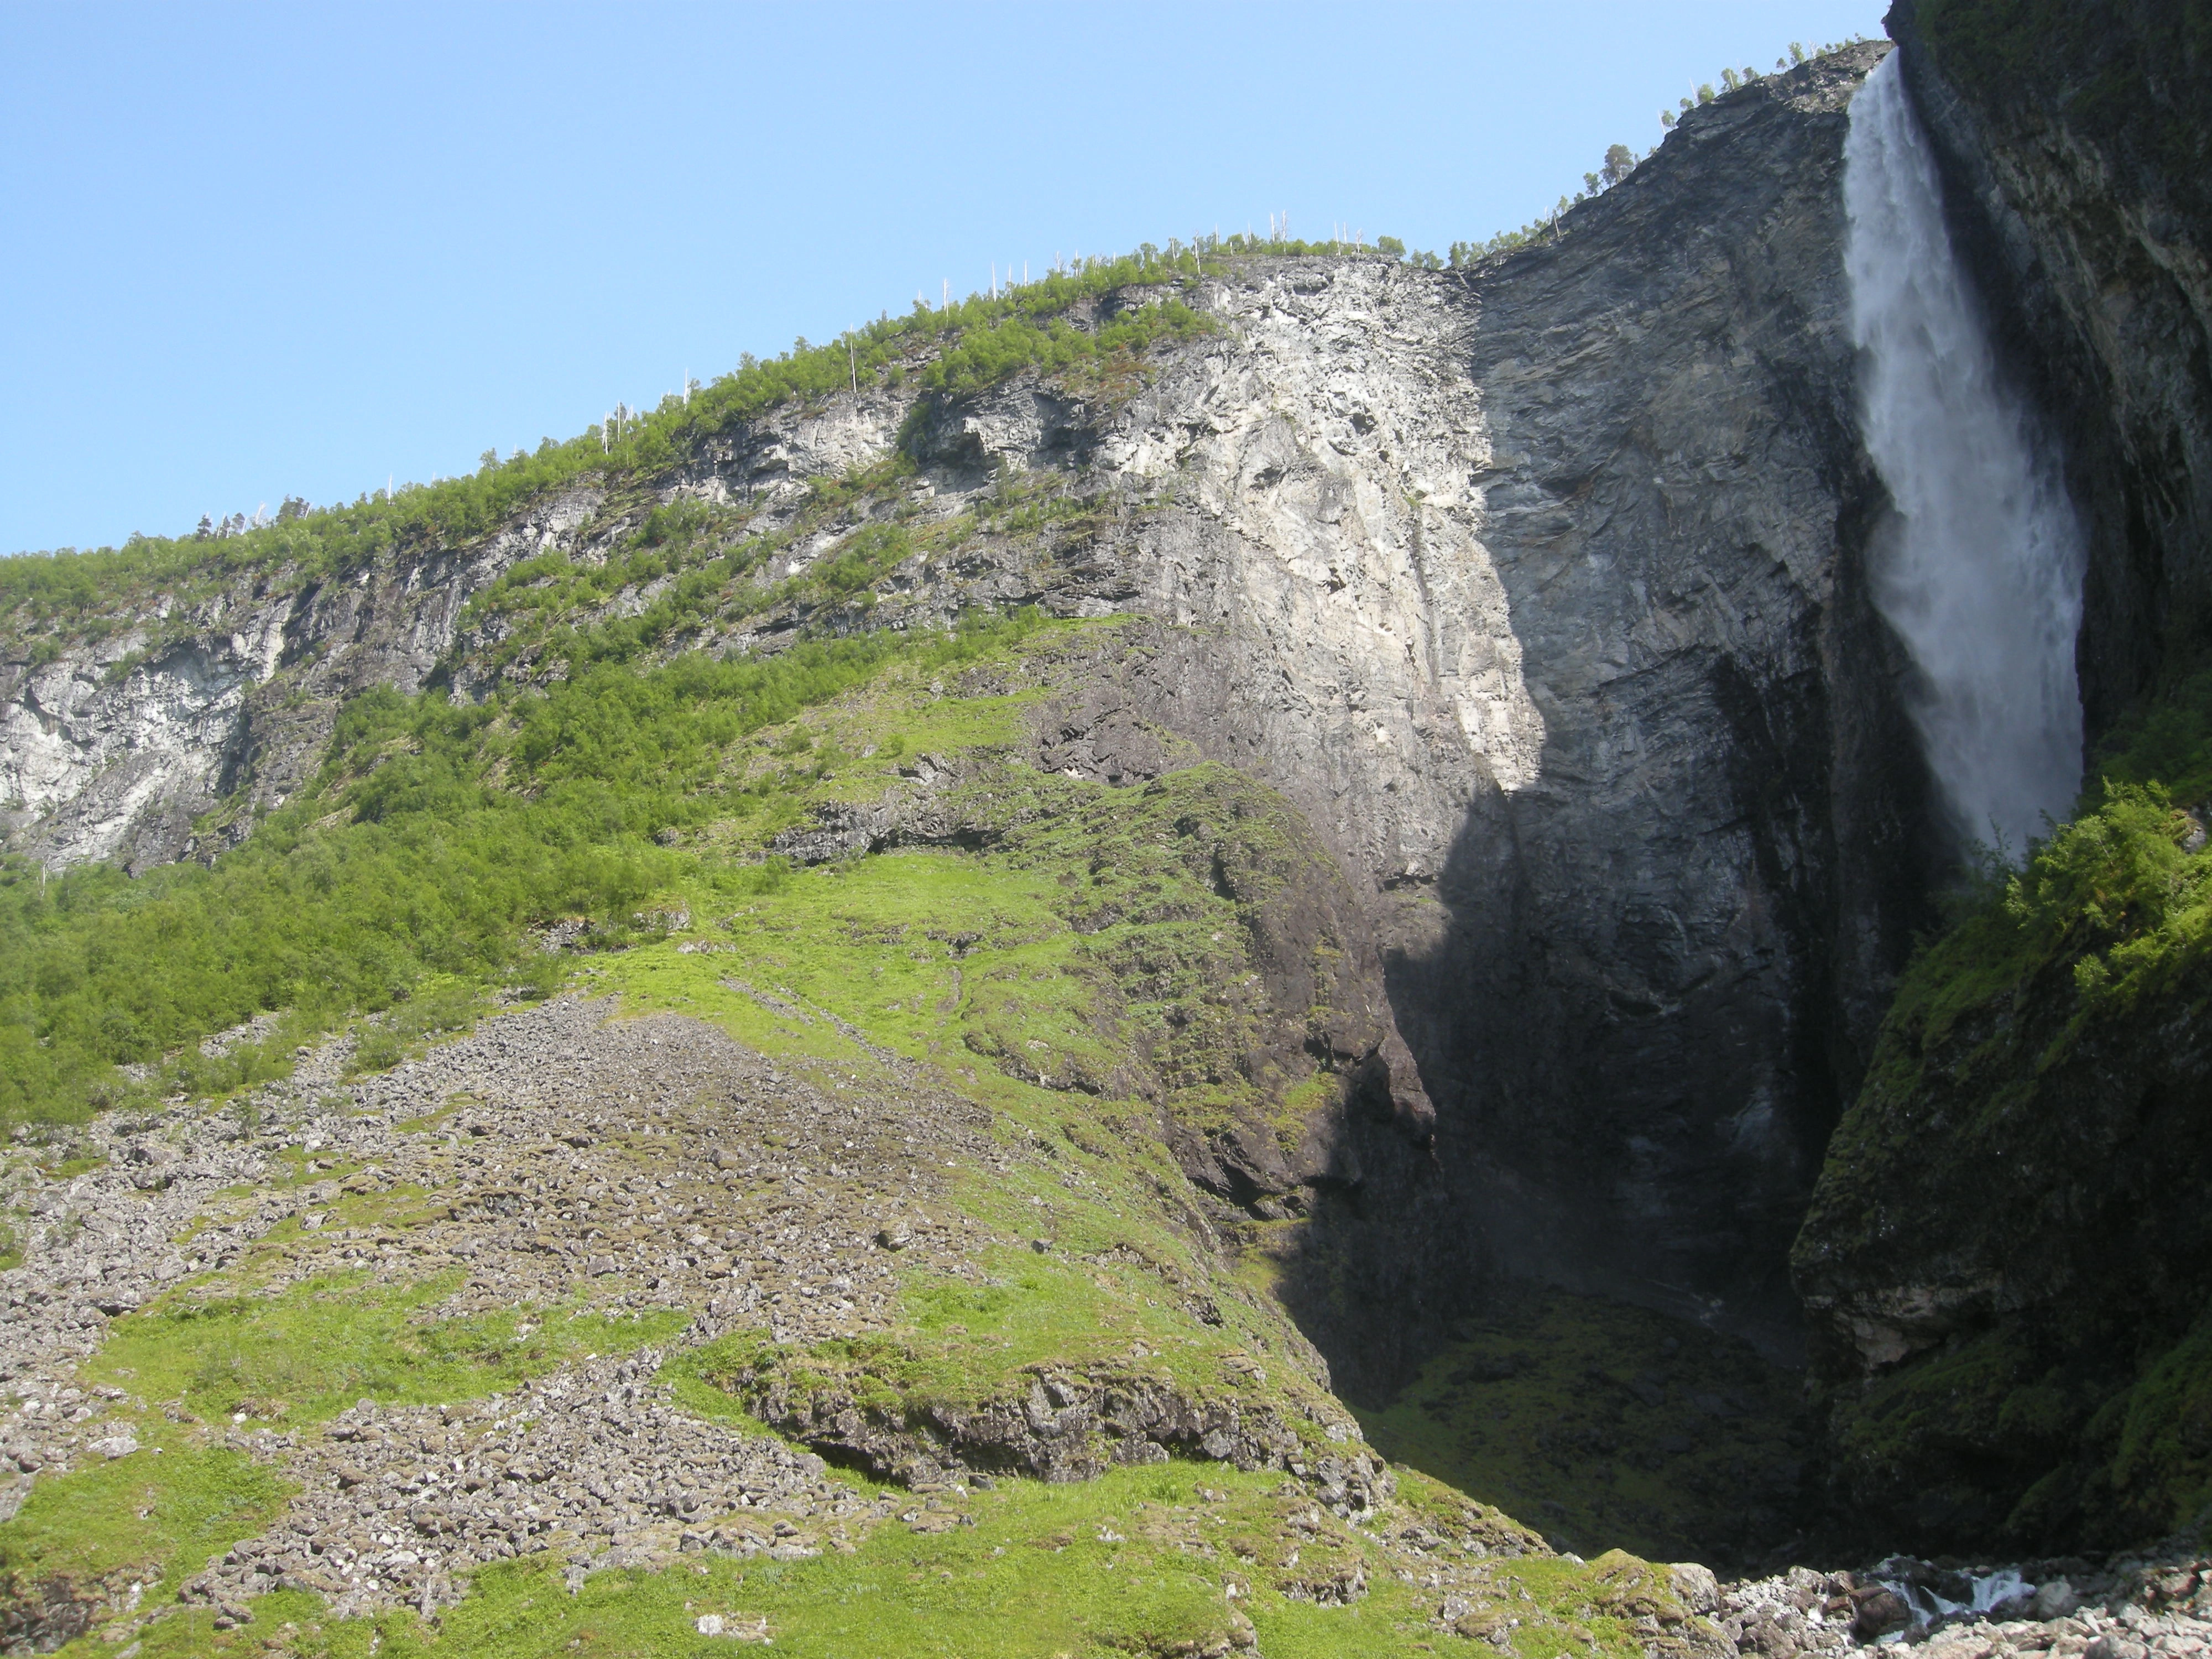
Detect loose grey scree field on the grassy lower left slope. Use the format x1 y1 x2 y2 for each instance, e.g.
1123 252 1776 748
0 998 1004 1617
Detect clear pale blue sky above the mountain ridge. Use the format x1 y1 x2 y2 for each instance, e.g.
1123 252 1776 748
0 0 1882 562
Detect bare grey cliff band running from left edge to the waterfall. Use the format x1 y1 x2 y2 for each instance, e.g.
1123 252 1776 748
0 46 1924 1394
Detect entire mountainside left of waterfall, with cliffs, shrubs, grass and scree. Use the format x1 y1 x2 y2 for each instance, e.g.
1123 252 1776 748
0 19 2194 1657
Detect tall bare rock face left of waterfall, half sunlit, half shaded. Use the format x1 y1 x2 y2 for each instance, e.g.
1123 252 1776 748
938 46 1924 1389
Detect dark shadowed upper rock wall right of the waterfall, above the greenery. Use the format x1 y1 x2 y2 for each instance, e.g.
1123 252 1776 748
1889 0 2212 734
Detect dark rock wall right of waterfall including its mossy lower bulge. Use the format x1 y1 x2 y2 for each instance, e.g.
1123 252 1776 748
1796 0 2212 1548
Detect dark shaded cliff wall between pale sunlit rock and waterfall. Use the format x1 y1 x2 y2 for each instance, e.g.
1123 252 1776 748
1285 49 1942 1559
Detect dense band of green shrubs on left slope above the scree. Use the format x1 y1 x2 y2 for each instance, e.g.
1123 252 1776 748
0 617 1031 1121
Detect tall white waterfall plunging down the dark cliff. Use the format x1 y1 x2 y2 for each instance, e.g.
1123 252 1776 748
1843 53 2084 858
